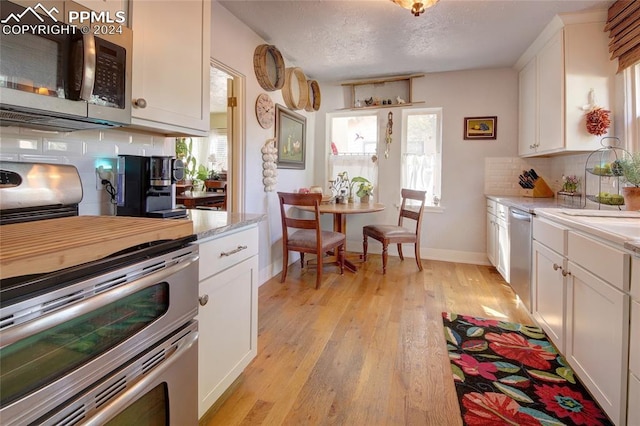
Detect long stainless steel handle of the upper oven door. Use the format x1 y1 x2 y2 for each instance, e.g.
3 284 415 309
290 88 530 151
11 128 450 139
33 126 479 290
0 254 198 349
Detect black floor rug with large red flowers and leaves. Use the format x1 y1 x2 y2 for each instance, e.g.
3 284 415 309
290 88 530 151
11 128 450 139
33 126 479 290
442 312 612 426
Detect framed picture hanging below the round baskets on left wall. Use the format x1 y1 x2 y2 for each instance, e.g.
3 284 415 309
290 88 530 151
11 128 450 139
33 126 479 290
276 104 307 169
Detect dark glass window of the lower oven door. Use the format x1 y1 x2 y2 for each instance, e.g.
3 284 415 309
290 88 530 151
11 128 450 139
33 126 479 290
105 383 169 426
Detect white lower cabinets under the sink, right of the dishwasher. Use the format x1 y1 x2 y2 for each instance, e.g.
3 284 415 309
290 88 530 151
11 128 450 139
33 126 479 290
532 216 640 425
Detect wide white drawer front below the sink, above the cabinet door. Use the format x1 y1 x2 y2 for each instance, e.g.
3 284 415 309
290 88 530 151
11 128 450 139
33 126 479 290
568 232 630 292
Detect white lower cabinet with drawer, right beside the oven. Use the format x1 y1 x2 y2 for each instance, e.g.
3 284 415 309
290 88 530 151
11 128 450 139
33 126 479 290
197 226 258 417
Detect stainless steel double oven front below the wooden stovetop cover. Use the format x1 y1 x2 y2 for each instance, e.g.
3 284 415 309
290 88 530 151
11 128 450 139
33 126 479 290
0 161 198 426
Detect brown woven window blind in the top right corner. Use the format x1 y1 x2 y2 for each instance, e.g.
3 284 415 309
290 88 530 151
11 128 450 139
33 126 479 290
604 0 640 73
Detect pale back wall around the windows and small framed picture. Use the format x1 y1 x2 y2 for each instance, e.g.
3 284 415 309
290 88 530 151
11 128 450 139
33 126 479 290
314 68 518 263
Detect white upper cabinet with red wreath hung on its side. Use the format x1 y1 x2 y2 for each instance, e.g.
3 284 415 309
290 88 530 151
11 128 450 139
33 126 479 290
516 12 616 157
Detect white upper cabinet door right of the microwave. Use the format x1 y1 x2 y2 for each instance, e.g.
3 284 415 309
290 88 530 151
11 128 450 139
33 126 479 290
129 0 211 136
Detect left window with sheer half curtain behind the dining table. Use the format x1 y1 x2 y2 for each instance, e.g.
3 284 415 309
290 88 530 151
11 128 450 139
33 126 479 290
327 111 378 196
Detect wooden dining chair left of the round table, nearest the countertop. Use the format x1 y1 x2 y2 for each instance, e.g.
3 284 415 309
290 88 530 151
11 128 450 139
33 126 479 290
278 192 346 288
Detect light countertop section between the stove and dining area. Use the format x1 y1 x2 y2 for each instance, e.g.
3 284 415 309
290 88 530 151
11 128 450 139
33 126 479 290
187 209 267 240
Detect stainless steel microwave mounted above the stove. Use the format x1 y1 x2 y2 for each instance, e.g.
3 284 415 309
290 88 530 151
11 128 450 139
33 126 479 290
0 0 133 131
